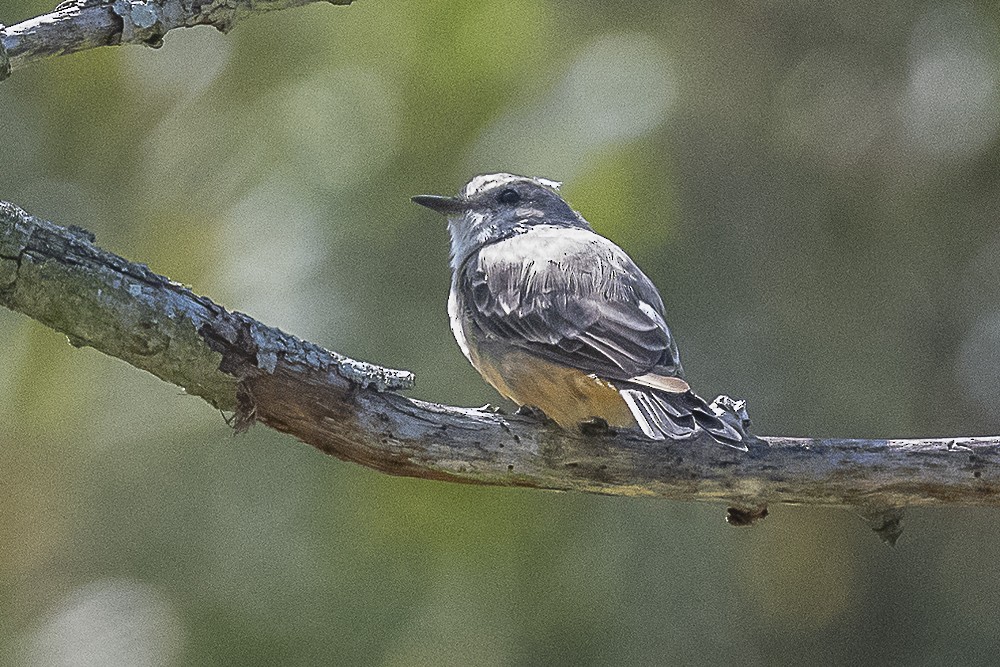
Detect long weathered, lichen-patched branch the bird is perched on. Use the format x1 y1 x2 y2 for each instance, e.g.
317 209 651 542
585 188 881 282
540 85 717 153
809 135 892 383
0 203 1000 522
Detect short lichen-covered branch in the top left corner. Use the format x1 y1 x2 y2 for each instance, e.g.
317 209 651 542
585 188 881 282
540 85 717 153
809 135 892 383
0 0 352 81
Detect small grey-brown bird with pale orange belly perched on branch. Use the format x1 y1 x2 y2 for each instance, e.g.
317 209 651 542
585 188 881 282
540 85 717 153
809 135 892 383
412 173 746 450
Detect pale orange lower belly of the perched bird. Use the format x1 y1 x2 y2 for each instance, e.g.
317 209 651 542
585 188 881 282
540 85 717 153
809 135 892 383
471 350 636 429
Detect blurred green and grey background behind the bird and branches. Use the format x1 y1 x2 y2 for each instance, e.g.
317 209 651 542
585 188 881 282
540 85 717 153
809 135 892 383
0 0 1000 665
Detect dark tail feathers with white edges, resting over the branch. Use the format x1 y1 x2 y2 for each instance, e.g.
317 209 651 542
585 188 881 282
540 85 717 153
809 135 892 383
619 387 747 451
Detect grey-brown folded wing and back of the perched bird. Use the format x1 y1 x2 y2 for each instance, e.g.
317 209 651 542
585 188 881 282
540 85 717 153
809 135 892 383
459 227 682 380
